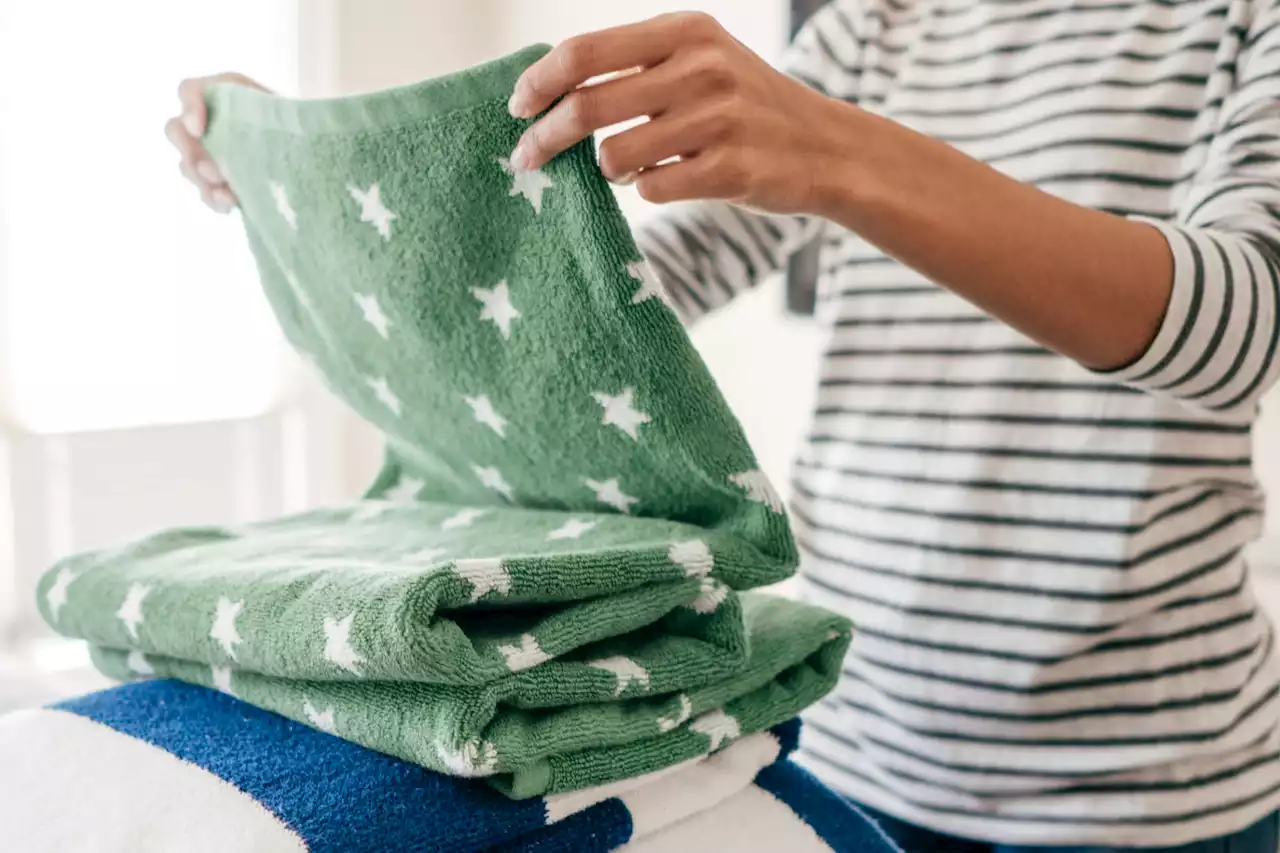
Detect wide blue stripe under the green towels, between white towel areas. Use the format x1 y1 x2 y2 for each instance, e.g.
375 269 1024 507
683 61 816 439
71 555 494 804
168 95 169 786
54 681 550 853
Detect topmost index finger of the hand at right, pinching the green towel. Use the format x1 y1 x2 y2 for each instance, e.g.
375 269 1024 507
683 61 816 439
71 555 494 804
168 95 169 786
507 13 719 118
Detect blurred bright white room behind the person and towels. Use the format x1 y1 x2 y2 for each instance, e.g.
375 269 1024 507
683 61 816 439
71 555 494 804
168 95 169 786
0 0 1280 710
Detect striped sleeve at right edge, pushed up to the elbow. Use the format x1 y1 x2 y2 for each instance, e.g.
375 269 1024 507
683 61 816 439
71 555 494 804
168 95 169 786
1101 0 1280 418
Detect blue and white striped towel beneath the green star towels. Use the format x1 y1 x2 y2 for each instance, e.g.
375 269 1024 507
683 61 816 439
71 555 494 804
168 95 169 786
0 680 895 853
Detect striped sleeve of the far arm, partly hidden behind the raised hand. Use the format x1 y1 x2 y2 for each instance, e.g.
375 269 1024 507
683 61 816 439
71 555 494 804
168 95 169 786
636 3 860 323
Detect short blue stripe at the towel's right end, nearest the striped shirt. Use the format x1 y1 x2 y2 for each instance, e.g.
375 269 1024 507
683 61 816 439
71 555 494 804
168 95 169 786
755 761 902 853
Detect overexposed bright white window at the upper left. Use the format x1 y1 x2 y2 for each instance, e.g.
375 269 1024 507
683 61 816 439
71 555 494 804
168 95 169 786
0 0 297 433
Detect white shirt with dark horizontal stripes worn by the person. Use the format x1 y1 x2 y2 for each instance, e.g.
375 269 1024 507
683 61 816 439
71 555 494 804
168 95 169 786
640 0 1280 847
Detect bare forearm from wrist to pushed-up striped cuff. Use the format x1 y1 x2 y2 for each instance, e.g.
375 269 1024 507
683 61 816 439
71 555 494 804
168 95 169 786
814 105 1172 369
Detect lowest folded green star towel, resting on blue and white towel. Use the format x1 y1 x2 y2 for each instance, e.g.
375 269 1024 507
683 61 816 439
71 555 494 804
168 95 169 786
93 593 849 797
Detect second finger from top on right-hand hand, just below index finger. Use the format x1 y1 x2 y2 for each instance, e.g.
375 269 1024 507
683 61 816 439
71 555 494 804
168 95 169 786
511 63 706 169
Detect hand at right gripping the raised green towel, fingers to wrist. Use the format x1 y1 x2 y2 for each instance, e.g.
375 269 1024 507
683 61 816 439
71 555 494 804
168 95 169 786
509 13 858 213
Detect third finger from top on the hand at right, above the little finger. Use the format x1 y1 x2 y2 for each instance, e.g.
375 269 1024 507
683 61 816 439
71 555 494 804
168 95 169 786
600 102 739 183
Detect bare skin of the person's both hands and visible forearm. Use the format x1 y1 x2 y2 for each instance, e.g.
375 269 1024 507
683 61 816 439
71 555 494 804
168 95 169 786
166 13 1172 368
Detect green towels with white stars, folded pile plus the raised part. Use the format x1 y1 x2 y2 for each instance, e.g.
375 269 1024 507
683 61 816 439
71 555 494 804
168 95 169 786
32 47 850 799
